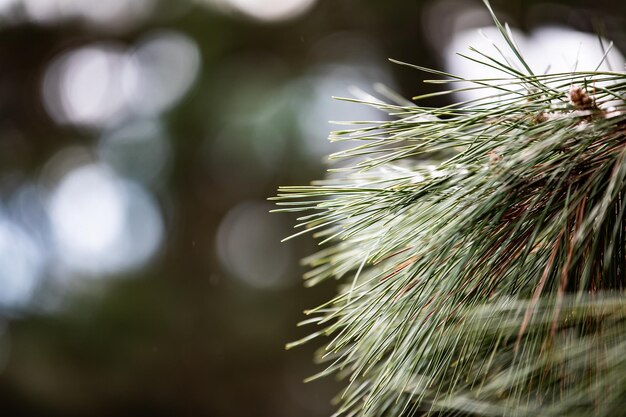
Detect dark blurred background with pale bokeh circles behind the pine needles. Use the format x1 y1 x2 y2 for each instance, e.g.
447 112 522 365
0 0 626 417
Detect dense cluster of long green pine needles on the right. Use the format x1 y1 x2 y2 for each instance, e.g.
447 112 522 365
274 4 626 417
